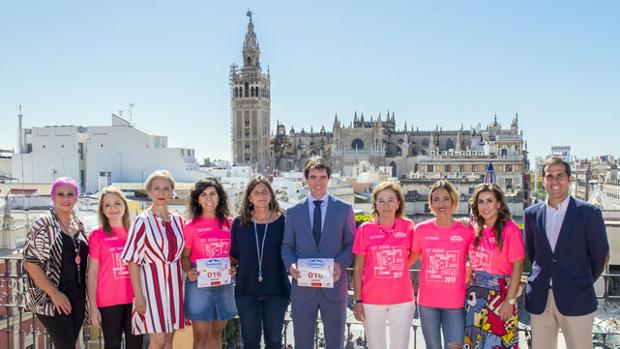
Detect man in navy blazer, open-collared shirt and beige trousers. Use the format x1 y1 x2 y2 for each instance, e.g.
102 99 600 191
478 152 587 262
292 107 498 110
524 157 609 349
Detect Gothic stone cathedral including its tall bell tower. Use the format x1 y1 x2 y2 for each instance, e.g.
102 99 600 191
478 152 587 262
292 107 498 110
230 11 529 191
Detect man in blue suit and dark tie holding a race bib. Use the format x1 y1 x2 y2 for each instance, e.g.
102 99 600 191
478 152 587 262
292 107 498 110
282 157 355 349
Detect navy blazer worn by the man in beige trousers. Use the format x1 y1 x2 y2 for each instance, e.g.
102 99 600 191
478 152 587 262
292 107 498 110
524 197 609 316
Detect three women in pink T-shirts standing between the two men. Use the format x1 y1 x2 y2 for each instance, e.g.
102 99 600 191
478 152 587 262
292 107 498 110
353 180 524 349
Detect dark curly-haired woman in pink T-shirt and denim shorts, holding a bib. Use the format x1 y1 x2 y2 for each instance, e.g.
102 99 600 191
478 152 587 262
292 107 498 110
181 177 237 348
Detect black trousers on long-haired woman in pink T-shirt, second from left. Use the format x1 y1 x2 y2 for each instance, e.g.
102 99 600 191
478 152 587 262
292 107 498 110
99 303 143 349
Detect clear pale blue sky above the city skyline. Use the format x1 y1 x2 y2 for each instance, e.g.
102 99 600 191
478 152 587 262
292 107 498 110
0 0 620 161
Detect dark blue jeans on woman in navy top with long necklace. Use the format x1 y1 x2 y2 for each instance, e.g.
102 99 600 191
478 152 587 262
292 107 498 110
235 296 288 349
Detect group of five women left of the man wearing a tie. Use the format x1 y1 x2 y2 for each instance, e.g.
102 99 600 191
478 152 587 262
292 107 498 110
24 170 290 349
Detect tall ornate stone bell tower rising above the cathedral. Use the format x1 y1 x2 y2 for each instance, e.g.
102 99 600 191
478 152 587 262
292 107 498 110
230 11 272 174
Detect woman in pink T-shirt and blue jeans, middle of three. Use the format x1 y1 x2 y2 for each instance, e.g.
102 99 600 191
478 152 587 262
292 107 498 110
409 180 474 349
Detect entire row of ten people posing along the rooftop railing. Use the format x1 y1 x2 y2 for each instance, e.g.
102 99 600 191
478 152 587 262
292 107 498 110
24 157 609 349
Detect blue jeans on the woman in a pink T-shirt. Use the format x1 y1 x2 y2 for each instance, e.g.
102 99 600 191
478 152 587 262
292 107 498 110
418 305 465 349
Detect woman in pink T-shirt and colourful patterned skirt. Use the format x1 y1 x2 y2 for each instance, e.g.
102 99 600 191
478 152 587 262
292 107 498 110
465 184 525 349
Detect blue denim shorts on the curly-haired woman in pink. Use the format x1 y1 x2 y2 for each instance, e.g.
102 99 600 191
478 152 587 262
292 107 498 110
185 279 237 321
